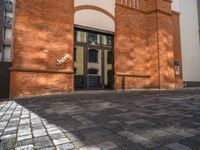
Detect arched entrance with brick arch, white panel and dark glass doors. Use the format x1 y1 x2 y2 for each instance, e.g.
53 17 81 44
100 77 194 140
74 5 114 90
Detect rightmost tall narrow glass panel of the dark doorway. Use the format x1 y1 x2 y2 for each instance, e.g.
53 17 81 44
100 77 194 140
104 50 113 88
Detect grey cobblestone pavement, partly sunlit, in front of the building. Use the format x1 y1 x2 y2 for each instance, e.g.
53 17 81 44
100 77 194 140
0 89 200 150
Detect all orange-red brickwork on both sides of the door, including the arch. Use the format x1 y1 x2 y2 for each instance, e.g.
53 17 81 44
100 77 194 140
10 0 182 97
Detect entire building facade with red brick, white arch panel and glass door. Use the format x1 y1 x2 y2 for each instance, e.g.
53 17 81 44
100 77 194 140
0 0 200 98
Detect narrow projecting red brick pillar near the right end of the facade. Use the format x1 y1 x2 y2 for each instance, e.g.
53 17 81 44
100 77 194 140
156 0 175 89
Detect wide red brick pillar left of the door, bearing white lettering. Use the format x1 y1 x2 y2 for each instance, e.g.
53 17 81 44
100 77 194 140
10 0 74 98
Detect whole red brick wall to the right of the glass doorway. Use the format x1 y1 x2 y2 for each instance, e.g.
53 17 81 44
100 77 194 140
115 0 180 89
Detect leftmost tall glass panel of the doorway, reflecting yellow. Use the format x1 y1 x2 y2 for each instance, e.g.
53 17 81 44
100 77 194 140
74 46 84 89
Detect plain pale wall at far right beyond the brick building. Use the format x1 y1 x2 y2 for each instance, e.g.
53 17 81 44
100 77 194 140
179 0 200 81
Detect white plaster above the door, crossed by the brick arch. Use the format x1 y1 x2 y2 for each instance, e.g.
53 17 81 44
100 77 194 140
74 0 115 31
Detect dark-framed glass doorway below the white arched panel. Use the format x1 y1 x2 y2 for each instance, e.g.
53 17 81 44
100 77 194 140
74 28 114 90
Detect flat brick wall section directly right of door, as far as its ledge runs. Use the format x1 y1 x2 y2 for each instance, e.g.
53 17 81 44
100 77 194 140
115 5 153 89
